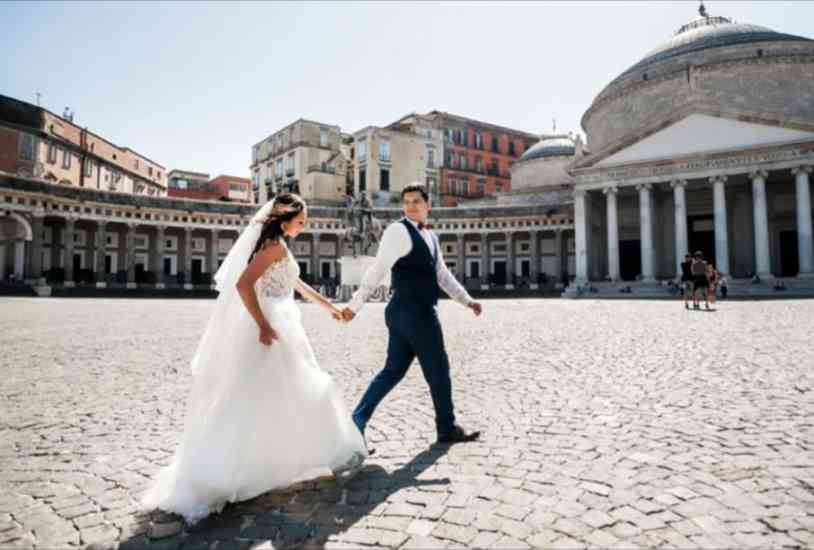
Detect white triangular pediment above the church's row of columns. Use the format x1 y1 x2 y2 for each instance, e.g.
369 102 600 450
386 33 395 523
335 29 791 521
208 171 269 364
591 113 814 167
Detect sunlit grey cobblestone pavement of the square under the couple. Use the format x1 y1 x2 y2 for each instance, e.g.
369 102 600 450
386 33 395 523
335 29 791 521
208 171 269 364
0 298 814 550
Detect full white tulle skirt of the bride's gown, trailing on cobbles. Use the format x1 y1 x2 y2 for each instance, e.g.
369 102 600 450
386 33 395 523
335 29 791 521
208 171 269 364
142 295 366 523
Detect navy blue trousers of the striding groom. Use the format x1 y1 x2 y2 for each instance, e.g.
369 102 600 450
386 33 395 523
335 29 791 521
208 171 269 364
353 296 455 437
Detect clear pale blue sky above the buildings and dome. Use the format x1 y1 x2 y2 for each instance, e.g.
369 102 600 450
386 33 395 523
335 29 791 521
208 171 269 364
0 0 814 177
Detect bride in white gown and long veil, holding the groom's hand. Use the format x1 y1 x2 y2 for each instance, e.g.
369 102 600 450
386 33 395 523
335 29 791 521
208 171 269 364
142 193 367 523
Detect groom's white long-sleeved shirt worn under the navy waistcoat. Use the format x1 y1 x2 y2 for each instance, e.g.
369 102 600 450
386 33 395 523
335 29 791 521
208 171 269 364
348 218 473 313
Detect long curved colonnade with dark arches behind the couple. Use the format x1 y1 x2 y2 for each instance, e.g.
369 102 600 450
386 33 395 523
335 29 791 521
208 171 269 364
0 174 575 294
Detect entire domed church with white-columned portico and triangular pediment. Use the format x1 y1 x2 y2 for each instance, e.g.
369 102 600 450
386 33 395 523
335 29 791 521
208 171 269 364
570 9 814 296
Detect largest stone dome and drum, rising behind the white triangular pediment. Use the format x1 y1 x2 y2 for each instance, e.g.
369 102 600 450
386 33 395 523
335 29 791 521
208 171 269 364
582 4 814 154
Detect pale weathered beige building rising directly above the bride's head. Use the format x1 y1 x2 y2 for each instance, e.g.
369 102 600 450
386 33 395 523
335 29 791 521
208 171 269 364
251 119 349 205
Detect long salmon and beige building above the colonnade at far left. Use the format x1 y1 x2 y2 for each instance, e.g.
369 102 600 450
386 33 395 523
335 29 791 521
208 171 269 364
0 95 167 196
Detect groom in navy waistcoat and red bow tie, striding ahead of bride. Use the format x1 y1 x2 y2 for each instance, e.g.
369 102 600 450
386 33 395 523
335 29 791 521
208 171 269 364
342 183 481 443
